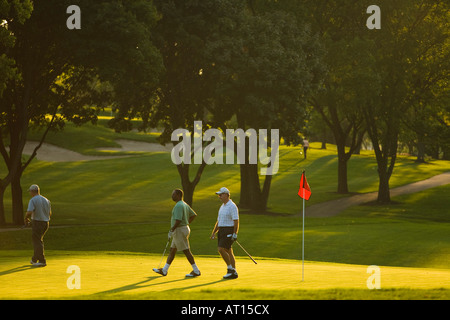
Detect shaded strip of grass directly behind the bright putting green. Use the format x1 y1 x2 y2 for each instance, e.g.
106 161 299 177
0 186 450 268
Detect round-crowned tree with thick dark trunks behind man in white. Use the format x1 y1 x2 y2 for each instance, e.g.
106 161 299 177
204 7 323 211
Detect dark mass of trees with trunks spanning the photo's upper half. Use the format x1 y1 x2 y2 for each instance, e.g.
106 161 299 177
0 0 450 224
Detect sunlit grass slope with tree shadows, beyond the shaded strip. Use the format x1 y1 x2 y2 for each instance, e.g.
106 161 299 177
0 144 450 224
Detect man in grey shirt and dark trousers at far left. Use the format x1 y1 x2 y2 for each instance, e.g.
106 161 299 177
25 184 52 267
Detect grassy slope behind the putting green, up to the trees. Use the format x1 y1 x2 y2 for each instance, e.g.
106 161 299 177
0 122 450 298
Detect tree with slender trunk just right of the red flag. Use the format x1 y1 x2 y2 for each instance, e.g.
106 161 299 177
311 38 370 193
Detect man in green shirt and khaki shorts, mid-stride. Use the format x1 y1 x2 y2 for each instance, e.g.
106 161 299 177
153 189 201 278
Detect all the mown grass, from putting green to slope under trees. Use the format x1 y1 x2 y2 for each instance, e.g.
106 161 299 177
0 126 450 299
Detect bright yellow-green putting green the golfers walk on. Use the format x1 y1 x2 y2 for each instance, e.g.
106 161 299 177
0 250 450 300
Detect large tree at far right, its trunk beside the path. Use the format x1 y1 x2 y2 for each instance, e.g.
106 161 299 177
363 0 449 203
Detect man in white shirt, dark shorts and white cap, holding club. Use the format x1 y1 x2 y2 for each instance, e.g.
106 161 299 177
211 187 239 279
